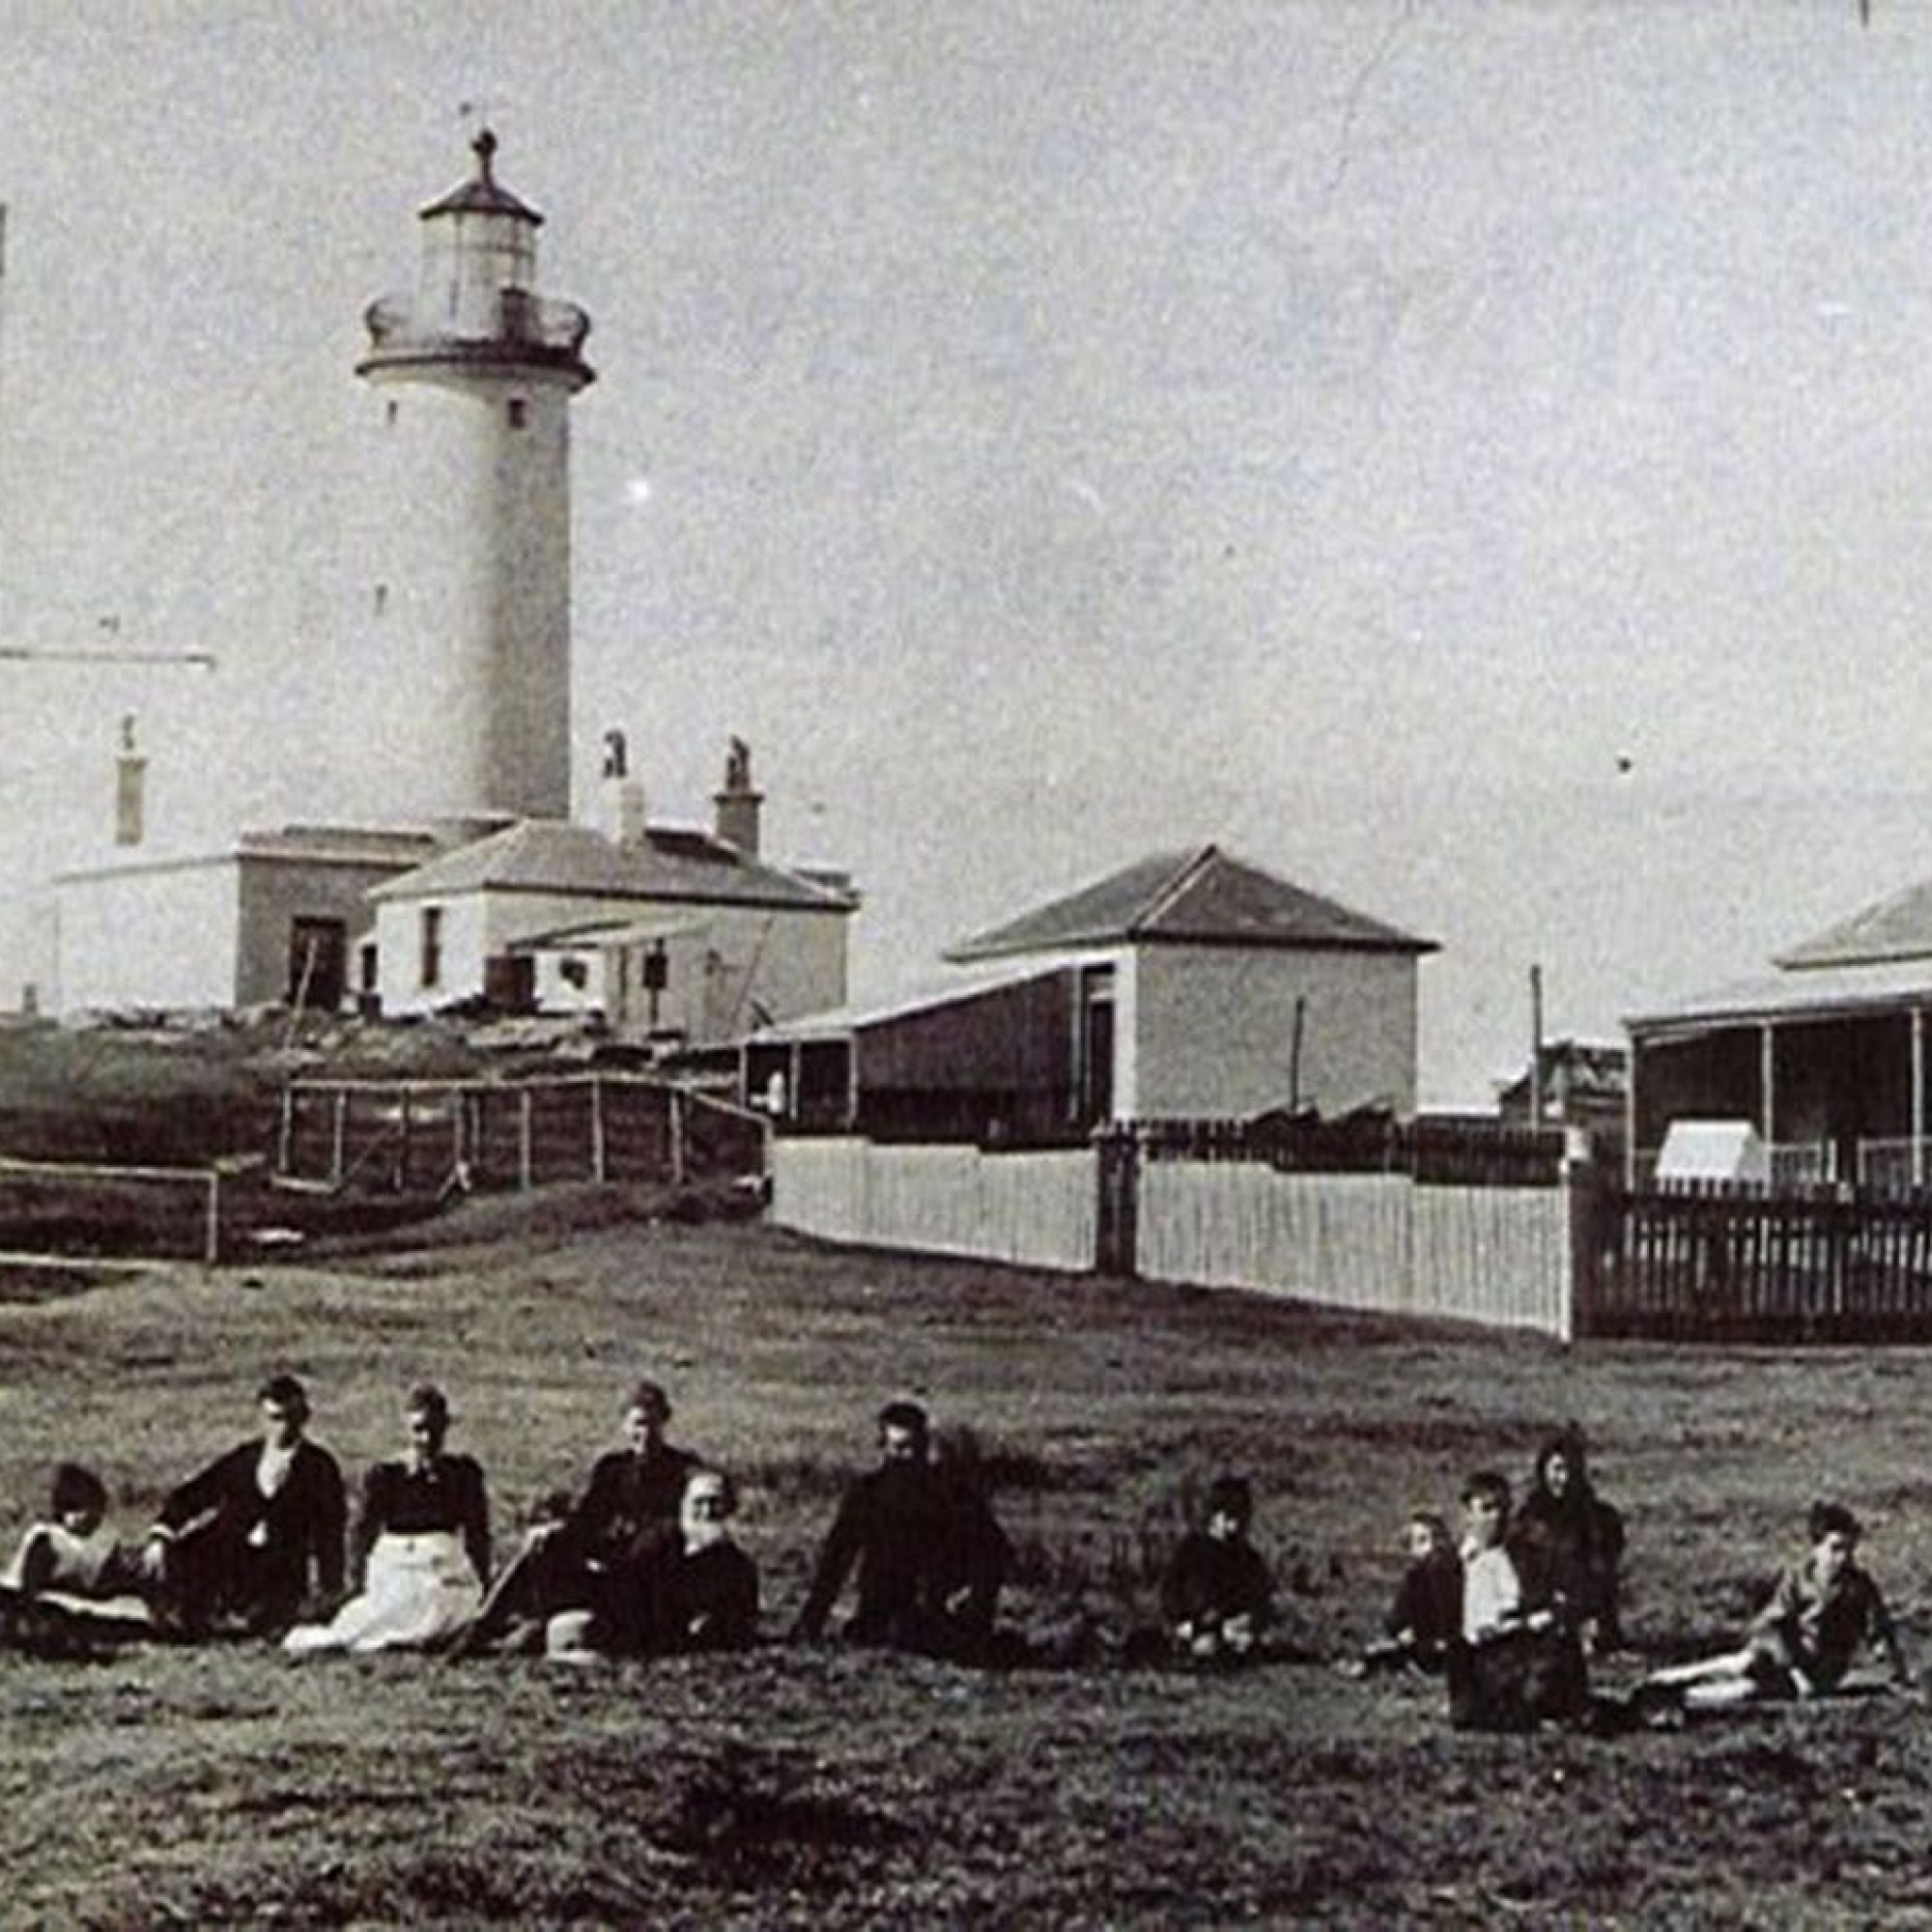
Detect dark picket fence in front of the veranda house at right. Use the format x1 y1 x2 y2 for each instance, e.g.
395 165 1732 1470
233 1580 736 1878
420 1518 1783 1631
1577 1188 1932 1343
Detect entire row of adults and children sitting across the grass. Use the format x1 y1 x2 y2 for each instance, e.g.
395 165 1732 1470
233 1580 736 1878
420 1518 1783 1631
0 1376 1913 1729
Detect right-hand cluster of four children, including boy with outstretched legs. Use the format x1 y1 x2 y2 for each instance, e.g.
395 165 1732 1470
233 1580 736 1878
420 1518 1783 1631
1345 1428 1915 1731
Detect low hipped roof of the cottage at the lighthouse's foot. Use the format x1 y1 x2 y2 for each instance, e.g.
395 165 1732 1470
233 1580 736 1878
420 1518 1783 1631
369 819 858 912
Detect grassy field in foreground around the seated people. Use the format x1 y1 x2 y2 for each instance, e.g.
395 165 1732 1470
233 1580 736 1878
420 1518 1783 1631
11 1198 1932 1928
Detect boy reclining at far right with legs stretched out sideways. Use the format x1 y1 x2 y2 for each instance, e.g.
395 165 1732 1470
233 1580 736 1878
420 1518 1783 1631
1636 1503 1915 1714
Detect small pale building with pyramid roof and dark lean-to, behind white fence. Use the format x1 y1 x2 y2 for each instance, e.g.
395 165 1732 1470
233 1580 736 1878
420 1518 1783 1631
744 844 1435 1140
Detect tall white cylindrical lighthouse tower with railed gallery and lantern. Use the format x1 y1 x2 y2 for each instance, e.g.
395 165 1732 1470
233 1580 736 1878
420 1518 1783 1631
352 128 593 823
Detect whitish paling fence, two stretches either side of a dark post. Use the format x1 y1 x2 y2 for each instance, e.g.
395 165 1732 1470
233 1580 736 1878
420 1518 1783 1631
771 1138 1575 1341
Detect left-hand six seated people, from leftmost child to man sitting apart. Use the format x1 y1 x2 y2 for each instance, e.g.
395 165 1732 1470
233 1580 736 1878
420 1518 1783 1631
0 1376 1010 1662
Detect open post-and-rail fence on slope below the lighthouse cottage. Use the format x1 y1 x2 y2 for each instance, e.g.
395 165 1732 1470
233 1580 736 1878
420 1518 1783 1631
276 1074 765 1194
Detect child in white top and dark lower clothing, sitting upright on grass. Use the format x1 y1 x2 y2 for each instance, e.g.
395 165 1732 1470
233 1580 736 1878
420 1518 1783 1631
1445 1470 1590 1731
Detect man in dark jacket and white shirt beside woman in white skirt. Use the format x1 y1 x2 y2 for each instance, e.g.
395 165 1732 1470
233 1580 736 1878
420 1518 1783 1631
143 1376 348 1636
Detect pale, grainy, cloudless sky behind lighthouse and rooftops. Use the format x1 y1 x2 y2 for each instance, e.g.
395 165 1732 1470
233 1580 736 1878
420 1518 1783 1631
0 0 1932 1105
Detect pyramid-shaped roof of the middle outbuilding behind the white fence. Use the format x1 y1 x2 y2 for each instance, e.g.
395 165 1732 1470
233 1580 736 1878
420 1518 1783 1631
947 844 1435 960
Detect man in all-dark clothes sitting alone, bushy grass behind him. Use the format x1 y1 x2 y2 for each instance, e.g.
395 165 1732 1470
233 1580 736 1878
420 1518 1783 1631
794 1403 1012 1662
